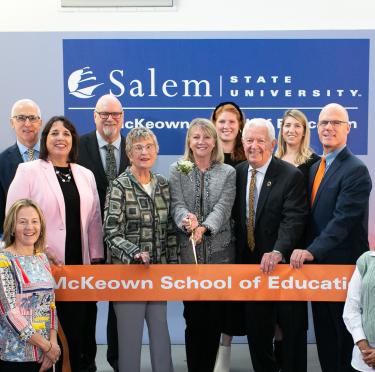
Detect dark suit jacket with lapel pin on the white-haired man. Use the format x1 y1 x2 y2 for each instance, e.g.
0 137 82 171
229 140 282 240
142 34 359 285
233 157 308 264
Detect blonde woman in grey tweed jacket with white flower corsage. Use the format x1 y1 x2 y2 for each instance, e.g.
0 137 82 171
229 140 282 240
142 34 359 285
169 119 236 372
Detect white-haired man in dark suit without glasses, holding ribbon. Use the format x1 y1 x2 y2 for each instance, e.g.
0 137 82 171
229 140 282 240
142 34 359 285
233 119 307 372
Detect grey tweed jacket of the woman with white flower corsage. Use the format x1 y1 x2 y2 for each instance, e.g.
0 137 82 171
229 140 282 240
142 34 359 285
169 163 236 264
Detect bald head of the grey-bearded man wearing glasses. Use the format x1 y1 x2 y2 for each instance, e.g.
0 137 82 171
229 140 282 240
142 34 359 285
94 94 124 143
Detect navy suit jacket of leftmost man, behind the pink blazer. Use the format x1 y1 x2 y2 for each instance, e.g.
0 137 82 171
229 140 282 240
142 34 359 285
0 143 23 234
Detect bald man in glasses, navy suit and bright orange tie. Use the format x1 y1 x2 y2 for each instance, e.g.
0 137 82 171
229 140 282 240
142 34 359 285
291 103 372 372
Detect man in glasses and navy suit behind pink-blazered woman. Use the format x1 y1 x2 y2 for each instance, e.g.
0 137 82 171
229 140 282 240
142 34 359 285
0 99 42 236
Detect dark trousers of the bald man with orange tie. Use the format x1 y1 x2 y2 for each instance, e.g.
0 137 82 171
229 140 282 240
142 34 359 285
312 302 354 372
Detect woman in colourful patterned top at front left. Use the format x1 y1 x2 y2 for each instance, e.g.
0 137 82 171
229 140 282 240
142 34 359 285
0 199 60 372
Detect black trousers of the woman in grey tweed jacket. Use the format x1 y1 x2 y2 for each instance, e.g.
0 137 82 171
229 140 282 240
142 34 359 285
184 301 222 372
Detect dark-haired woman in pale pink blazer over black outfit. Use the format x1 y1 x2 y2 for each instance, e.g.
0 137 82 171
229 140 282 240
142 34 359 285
7 116 103 371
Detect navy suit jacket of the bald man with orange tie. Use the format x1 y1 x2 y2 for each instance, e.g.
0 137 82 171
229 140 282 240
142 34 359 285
306 147 372 264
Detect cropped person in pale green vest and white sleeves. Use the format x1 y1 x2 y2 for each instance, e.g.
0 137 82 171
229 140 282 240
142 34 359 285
343 251 375 372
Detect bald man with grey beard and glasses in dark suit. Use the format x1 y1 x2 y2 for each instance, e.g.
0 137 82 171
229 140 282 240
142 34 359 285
78 94 129 372
